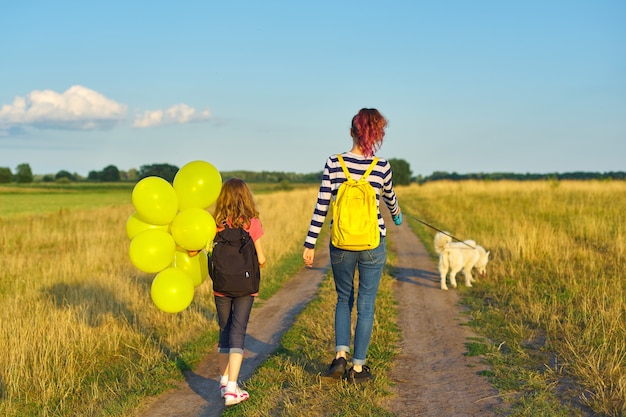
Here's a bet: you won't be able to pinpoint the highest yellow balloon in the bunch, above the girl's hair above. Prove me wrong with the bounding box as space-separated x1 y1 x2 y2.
174 161 222 211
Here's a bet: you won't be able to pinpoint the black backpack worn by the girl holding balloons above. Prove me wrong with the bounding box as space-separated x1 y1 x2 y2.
208 224 261 297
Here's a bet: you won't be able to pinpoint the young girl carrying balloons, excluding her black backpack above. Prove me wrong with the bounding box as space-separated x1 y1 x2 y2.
214 178 265 406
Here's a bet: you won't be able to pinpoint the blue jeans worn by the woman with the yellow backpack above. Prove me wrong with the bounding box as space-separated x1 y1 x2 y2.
330 236 387 365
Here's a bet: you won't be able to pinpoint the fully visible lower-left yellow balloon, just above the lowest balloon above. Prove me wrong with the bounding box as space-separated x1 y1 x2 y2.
128 229 176 274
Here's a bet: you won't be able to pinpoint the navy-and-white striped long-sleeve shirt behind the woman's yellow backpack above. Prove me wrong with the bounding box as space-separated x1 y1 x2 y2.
304 152 400 249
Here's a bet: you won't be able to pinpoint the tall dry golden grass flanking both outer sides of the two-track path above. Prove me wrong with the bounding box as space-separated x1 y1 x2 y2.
0 182 626 417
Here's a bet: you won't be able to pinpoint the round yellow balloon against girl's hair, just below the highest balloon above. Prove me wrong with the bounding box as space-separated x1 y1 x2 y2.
170 208 216 250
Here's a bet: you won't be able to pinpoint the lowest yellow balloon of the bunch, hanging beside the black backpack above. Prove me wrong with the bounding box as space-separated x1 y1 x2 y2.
150 268 194 313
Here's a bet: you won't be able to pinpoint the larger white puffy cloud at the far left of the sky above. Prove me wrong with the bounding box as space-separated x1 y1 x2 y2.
0 85 127 130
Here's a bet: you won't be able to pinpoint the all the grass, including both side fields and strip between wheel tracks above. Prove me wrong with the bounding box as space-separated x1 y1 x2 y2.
0 181 626 417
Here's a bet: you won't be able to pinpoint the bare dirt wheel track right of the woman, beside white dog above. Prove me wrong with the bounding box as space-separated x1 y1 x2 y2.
382 214 500 417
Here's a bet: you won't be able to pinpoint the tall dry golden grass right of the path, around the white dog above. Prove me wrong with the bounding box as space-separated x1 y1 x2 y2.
398 182 626 416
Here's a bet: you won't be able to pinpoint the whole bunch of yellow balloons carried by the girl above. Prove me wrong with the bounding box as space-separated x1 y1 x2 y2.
126 161 222 313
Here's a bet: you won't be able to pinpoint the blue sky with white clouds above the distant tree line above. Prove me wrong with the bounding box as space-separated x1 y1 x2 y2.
0 0 626 175
